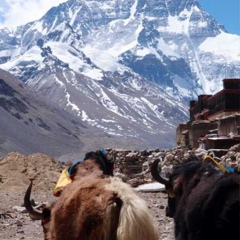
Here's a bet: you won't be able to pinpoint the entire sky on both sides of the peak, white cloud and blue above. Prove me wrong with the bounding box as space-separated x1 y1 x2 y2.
0 0 240 35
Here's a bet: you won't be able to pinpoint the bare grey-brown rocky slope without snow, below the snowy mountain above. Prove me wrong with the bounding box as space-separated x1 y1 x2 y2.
0 70 164 160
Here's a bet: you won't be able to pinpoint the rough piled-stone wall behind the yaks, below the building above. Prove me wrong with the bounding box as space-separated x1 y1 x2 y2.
108 144 240 187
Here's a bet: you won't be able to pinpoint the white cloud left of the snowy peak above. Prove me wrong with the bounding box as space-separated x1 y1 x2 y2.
0 0 67 28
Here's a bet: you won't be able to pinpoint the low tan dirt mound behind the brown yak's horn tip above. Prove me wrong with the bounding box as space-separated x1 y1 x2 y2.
0 152 62 190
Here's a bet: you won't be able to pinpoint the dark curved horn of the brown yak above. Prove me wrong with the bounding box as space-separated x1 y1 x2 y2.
24 180 43 220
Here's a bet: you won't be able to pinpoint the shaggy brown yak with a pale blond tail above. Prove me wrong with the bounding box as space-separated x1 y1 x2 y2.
24 149 159 240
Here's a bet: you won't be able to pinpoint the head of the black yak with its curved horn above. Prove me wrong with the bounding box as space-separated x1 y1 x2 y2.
151 157 201 217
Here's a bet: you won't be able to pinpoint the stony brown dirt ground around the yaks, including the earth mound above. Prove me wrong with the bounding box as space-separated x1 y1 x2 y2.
0 153 174 240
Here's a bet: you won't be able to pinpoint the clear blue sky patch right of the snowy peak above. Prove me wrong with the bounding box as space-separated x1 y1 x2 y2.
198 0 240 35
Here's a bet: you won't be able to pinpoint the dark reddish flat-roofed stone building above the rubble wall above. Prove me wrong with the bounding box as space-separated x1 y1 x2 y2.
176 78 240 149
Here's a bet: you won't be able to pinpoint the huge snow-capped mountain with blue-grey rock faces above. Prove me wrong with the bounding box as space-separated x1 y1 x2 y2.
0 0 240 147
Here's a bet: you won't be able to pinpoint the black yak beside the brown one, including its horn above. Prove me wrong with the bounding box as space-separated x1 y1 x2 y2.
151 157 240 240
